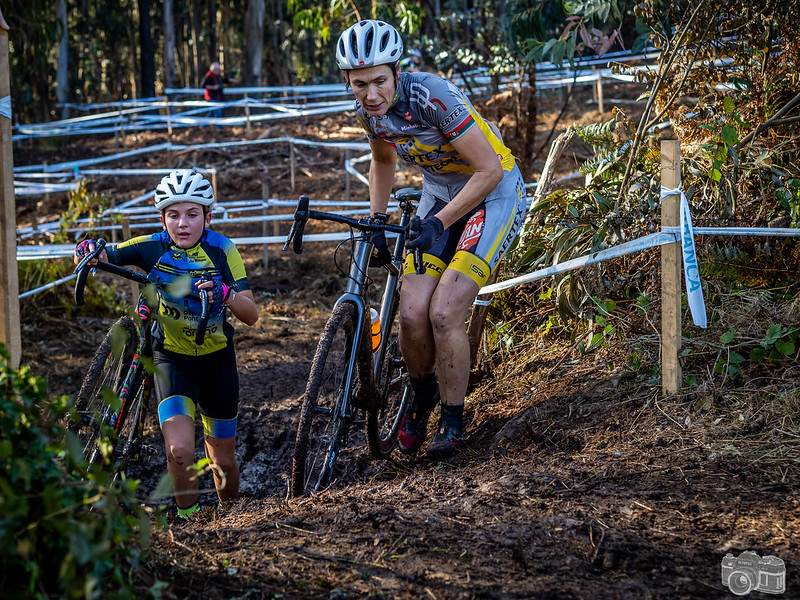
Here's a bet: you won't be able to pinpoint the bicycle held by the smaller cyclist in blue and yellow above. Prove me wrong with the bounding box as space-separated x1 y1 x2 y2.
68 239 210 478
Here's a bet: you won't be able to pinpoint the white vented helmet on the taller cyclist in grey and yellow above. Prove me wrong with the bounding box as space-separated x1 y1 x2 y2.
336 19 403 71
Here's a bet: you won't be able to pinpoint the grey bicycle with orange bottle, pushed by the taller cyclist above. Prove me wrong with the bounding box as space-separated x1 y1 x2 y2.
284 188 422 497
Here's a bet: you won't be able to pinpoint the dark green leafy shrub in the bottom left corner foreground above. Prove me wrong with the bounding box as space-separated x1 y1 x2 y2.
0 345 159 599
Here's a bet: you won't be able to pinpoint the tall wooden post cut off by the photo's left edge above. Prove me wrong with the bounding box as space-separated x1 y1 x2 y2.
0 12 22 369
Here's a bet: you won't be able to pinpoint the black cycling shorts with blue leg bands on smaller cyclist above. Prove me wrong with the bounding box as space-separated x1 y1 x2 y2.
153 344 239 439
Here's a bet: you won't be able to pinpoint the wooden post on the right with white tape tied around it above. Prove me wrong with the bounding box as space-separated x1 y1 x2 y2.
661 140 682 396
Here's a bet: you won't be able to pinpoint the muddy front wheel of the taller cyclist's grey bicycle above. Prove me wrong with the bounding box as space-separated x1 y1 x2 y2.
292 303 356 496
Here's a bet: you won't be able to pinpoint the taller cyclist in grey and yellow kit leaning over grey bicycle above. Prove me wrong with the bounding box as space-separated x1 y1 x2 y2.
336 20 526 458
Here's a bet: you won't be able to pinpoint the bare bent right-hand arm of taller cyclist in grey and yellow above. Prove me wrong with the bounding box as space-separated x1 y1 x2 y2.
432 125 503 229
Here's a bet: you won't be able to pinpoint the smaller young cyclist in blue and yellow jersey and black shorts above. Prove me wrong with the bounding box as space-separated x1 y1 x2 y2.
75 170 258 518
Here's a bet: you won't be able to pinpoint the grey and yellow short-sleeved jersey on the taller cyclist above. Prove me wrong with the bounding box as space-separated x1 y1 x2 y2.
355 73 514 189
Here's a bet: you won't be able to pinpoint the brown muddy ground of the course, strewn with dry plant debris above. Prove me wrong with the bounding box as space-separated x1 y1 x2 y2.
15 82 800 600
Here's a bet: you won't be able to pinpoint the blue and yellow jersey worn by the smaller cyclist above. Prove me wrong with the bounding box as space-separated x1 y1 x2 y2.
106 229 250 356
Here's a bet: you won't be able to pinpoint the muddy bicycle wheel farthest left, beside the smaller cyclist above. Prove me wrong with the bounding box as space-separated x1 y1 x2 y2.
69 317 139 464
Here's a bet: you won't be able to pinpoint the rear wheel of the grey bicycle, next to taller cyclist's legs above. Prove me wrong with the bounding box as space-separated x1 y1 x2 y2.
367 297 412 458
